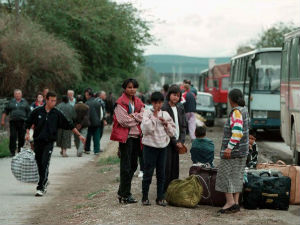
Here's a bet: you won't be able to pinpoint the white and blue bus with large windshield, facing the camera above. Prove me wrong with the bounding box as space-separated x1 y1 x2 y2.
228 48 281 131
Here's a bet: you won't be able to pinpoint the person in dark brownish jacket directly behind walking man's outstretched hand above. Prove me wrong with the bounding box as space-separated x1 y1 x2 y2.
74 95 90 157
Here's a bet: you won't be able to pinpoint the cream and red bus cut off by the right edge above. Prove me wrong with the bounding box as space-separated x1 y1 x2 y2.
280 28 300 165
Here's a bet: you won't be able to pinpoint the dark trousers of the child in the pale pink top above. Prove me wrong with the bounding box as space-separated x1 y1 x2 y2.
142 145 167 200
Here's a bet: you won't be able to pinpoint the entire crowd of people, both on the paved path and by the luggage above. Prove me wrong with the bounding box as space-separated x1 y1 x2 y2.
1 79 257 213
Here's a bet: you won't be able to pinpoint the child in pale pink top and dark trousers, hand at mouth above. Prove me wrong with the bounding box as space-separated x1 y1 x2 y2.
141 92 176 206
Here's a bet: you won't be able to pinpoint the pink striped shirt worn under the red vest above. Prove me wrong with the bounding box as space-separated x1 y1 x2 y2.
115 104 144 137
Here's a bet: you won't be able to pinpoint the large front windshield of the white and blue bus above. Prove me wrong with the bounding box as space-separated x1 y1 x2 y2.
252 52 281 92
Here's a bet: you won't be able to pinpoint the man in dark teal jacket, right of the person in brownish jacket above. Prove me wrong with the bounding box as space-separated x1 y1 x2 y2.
84 88 102 155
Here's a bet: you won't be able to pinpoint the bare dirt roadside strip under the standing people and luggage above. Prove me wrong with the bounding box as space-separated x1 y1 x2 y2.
26 121 300 225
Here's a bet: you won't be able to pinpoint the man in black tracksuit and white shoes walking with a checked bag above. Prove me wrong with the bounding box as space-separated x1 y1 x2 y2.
25 92 85 196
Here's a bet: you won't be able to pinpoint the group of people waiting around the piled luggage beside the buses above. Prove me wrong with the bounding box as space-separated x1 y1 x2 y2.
110 79 257 213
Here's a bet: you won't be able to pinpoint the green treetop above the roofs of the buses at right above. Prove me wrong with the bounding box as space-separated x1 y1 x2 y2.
252 22 296 48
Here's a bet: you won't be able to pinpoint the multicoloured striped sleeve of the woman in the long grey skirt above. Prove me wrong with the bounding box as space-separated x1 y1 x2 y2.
227 109 243 149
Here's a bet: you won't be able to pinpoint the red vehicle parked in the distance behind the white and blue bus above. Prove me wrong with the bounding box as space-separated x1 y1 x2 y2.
199 63 230 117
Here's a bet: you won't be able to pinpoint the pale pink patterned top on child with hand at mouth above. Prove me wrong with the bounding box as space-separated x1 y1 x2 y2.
141 110 176 148
